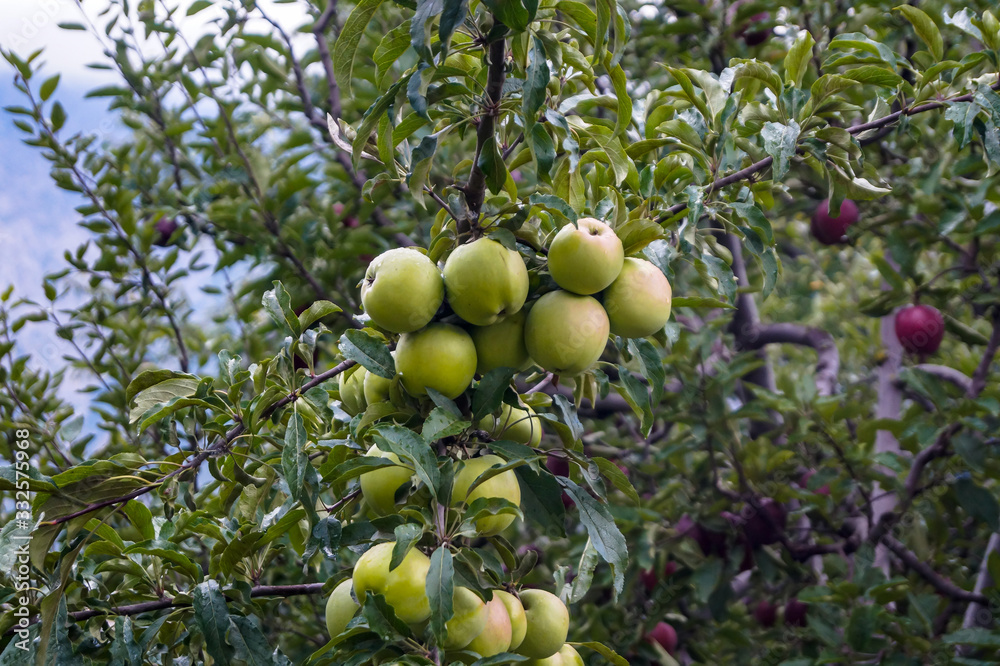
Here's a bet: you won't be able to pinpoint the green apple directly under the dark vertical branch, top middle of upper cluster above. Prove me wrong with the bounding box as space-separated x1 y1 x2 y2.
444 238 528 326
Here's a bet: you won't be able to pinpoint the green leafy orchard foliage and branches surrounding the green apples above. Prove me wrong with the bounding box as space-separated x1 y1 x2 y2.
0 0 1000 666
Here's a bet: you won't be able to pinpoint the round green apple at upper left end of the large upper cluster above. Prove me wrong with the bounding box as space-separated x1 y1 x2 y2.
361 247 444 333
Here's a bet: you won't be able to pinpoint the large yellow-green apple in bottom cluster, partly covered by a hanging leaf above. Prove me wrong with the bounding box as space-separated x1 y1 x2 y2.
354 541 431 624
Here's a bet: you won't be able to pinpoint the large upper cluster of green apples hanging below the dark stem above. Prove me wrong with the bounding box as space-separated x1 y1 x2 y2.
341 218 671 413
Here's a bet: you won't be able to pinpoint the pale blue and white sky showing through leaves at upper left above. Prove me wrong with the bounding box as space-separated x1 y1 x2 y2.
0 0 305 426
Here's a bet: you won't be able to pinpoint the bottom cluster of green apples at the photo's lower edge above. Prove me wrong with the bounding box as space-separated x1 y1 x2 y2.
326 542 583 666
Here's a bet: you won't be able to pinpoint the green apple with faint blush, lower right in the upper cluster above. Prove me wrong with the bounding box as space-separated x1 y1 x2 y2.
524 291 610 376
